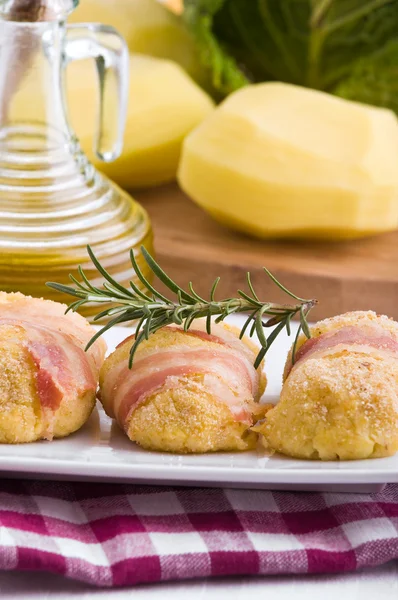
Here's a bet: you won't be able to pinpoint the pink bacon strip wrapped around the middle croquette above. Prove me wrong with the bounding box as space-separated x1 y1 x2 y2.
101 327 258 427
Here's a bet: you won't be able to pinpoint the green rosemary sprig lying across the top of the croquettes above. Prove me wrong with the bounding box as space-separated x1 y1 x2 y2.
47 246 316 368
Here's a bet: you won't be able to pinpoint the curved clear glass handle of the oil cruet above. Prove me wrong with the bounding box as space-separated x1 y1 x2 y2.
64 23 129 162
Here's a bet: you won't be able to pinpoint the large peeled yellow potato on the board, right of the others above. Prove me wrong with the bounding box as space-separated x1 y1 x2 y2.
178 83 398 239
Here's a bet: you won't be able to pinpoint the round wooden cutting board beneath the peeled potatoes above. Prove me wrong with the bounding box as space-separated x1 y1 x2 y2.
135 184 398 319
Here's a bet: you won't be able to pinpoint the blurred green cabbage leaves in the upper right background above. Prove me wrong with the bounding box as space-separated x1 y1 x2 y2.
184 0 398 111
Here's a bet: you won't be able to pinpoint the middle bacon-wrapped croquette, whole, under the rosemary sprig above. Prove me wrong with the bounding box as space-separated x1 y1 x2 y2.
100 320 265 453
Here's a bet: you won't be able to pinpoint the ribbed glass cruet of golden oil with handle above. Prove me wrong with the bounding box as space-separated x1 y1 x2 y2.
0 0 152 318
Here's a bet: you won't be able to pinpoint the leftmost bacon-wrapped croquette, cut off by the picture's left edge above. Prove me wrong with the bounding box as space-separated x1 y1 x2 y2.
0 292 106 443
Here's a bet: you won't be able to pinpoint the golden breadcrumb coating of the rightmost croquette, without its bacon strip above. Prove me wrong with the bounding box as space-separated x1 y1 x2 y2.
256 311 398 460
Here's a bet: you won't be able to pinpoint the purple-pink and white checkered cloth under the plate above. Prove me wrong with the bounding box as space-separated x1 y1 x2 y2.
0 481 398 586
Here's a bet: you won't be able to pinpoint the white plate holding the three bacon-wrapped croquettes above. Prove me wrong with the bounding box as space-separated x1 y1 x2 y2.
0 317 398 492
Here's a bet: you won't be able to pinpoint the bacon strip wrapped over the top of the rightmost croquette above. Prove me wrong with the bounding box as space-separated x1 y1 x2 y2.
285 325 398 378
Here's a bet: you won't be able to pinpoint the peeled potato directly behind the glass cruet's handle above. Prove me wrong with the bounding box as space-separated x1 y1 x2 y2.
67 55 213 189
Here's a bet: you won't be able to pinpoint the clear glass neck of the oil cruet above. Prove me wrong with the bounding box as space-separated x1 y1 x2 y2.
0 19 72 146
